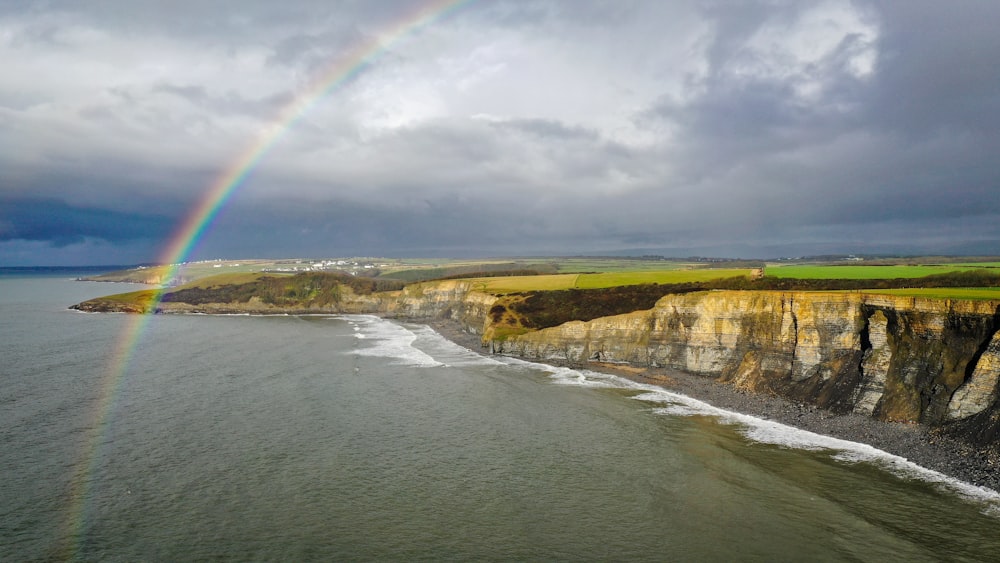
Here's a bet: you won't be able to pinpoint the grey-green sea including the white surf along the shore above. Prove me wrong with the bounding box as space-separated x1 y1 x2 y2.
0 272 1000 561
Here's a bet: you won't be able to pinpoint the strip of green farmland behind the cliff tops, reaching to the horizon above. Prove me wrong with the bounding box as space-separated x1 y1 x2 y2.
80 257 1000 299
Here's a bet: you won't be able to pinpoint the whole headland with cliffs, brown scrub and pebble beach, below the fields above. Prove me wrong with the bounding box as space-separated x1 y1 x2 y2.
74 260 1000 490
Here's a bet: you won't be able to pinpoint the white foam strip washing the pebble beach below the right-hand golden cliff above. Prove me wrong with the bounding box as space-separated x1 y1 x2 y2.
510 358 1000 518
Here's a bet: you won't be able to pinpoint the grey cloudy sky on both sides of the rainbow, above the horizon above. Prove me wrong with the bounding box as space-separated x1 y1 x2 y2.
0 0 1000 266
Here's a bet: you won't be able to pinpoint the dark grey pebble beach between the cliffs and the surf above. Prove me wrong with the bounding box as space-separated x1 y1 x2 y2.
418 319 1000 493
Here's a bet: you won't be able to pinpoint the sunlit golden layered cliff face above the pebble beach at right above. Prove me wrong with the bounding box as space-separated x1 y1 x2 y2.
492 291 1000 438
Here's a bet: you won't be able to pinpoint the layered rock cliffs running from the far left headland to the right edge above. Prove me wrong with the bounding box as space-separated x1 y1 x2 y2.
75 278 1000 444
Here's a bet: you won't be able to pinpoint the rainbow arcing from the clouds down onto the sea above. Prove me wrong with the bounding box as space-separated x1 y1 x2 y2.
63 0 475 559
